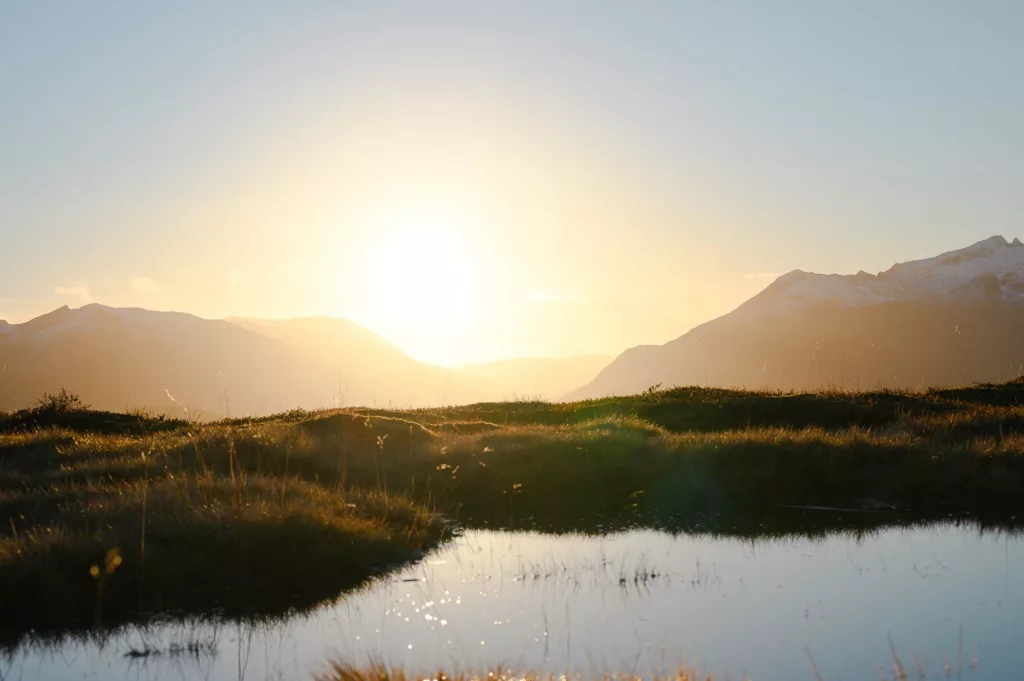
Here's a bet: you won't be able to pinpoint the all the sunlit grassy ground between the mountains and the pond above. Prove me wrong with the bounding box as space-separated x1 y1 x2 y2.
6 382 1024 638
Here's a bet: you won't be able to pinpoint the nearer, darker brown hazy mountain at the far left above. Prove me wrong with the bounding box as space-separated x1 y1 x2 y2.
0 304 311 416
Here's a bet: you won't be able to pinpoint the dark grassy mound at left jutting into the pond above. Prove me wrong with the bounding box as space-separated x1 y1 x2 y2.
0 417 444 641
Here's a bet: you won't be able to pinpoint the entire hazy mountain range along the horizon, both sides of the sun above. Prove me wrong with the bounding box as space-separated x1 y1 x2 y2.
0 237 1024 411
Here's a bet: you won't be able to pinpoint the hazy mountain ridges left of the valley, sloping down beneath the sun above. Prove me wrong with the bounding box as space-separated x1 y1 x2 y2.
0 304 487 411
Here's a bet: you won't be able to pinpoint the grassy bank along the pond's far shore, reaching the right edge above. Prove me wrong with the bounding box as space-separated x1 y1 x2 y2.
211 382 1024 524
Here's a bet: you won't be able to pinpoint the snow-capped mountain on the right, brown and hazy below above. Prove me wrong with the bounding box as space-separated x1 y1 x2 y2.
570 237 1024 398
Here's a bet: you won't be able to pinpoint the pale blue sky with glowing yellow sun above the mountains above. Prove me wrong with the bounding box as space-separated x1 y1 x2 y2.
0 0 1024 366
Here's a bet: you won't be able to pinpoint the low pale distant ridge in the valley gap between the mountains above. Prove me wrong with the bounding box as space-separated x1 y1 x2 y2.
459 354 613 400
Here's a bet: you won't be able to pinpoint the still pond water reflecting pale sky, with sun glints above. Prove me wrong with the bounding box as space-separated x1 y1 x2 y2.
0 525 1024 681
